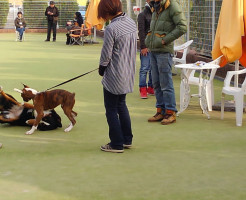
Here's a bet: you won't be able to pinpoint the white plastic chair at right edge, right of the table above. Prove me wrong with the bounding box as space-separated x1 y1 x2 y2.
221 69 246 126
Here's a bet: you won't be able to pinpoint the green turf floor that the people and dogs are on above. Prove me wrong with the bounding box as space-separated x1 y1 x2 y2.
0 33 246 200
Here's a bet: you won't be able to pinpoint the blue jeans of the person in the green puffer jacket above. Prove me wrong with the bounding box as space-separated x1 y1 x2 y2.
150 52 177 114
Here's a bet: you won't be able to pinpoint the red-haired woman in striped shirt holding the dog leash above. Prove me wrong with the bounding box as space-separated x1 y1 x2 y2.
98 0 137 153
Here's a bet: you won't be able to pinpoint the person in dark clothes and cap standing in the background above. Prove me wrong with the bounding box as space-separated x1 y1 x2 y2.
45 1 59 42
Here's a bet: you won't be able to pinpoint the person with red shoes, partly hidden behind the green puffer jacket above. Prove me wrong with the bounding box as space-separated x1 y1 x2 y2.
138 0 154 99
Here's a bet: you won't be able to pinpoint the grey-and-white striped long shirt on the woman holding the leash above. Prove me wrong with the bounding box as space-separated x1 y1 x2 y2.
100 14 137 95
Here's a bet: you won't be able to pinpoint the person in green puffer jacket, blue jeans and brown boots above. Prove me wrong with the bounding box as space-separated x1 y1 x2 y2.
145 0 187 125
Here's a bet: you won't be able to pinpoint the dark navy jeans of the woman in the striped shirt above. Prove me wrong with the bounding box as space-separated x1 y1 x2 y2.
103 89 133 149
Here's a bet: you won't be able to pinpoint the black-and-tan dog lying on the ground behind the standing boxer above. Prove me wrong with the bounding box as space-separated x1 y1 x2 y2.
0 86 62 131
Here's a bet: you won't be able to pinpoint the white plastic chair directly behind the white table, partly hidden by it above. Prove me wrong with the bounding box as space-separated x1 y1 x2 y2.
189 55 223 111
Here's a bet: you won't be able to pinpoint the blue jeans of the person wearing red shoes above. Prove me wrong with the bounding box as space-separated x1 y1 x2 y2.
139 53 152 87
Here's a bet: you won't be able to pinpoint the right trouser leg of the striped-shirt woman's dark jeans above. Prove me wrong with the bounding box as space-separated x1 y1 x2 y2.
118 94 133 145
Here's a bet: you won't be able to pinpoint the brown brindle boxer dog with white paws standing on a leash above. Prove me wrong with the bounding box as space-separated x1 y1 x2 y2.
15 84 77 135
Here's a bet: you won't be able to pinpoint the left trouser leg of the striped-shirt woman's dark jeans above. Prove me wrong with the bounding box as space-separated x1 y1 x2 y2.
103 89 124 149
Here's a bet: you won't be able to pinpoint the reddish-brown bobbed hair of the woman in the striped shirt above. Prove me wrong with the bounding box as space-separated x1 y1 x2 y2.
97 0 122 20
